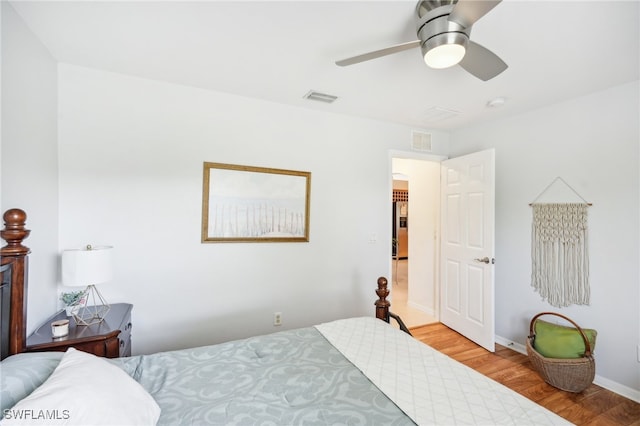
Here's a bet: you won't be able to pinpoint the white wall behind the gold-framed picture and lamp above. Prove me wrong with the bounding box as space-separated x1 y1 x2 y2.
59 65 448 353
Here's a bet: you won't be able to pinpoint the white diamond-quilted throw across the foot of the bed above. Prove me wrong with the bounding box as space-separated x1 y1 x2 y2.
316 318 571 425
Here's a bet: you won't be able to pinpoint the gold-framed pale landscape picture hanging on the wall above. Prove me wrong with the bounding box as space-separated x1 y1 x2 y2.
202 162 311 243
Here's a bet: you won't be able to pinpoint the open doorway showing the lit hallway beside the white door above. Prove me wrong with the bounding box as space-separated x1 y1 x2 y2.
390 152 443 327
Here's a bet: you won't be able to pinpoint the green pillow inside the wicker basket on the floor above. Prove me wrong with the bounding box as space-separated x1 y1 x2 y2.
533 320 597 359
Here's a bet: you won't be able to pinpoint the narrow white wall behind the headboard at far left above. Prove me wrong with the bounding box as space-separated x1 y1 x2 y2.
0 1 58 332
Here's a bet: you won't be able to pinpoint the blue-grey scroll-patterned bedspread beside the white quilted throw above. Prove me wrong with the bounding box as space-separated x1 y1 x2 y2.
114 327 414 426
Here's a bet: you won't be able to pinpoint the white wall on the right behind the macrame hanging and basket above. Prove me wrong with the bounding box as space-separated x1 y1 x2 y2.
451 82 640 398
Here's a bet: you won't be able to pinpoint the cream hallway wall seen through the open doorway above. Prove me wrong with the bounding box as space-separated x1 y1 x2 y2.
391 158 441 317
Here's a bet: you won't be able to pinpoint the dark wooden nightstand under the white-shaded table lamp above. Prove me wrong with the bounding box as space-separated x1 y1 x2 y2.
26 303 133 358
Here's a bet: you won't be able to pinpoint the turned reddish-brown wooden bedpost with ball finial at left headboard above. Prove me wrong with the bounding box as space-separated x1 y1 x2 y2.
0 209 31 355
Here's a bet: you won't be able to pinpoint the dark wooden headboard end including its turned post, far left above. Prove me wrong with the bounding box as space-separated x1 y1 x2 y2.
0 209 31 359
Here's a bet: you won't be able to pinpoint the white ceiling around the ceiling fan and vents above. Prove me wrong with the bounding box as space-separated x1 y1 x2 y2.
11 0 640 130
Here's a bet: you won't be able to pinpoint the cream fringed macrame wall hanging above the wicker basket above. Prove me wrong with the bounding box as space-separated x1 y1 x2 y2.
530 177 591 307
